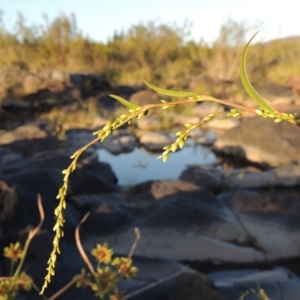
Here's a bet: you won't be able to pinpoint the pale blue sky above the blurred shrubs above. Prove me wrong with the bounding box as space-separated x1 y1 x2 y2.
0 0 300 42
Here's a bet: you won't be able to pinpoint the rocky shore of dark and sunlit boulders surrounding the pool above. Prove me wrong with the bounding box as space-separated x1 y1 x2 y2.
0 72 300 300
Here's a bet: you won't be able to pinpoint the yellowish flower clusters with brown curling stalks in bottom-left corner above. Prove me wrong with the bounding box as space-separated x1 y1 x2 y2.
0 195 140 300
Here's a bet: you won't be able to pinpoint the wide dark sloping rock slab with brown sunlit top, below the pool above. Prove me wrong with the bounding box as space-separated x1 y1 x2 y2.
83 181 264 263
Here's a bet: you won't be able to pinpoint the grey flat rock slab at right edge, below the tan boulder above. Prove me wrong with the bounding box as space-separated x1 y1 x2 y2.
218 190 300 261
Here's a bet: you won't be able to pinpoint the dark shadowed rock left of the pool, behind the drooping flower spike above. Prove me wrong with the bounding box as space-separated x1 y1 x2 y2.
0 150 117 240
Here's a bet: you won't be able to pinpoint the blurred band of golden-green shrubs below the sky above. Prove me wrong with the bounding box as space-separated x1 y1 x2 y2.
0 14 300 97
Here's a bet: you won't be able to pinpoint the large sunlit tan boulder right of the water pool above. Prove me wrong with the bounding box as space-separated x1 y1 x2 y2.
214 117 300 166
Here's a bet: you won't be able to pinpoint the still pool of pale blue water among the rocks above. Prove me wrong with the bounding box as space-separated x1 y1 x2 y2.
98 145 216 185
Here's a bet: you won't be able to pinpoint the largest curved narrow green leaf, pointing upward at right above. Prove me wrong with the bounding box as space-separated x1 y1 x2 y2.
240 32 275 112
